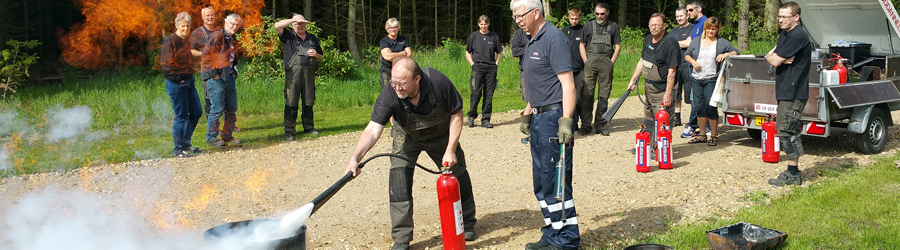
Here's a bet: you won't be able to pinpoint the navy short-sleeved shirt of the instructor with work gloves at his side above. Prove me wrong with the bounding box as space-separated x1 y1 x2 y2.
522 21 572 107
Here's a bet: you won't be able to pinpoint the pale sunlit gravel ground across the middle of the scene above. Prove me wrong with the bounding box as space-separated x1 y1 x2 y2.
0 98 900 249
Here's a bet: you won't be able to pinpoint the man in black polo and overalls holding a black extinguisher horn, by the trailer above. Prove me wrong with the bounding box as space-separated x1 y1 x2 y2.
628 13 684 146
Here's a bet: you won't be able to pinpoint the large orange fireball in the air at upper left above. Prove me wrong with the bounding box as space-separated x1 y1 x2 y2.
59 0 265 69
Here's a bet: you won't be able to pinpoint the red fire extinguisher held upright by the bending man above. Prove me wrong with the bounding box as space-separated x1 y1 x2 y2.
437 162 466 250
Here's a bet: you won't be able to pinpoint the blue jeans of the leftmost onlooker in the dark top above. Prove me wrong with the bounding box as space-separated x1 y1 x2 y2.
166 78 203 153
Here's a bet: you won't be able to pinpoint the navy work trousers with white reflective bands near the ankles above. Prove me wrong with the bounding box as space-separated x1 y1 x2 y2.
531 109 581 249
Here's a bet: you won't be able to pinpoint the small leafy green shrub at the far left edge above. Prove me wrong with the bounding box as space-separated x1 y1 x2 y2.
0 40 41 99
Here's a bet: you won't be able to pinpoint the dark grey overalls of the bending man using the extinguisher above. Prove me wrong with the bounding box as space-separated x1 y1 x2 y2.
388 78 476 243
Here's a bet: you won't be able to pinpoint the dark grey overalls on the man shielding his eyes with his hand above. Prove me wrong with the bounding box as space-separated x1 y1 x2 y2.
284 40 319 134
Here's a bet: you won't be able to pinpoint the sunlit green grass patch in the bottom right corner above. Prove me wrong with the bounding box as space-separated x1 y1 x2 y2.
628 154 900 249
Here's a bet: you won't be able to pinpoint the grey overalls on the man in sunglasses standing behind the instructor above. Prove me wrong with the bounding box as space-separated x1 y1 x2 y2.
581 21 615 130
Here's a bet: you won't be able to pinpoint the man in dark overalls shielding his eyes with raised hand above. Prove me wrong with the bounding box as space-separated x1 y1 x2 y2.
275 14 322 141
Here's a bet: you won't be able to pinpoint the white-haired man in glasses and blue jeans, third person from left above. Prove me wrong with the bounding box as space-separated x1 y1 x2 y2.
200 13 242 147
